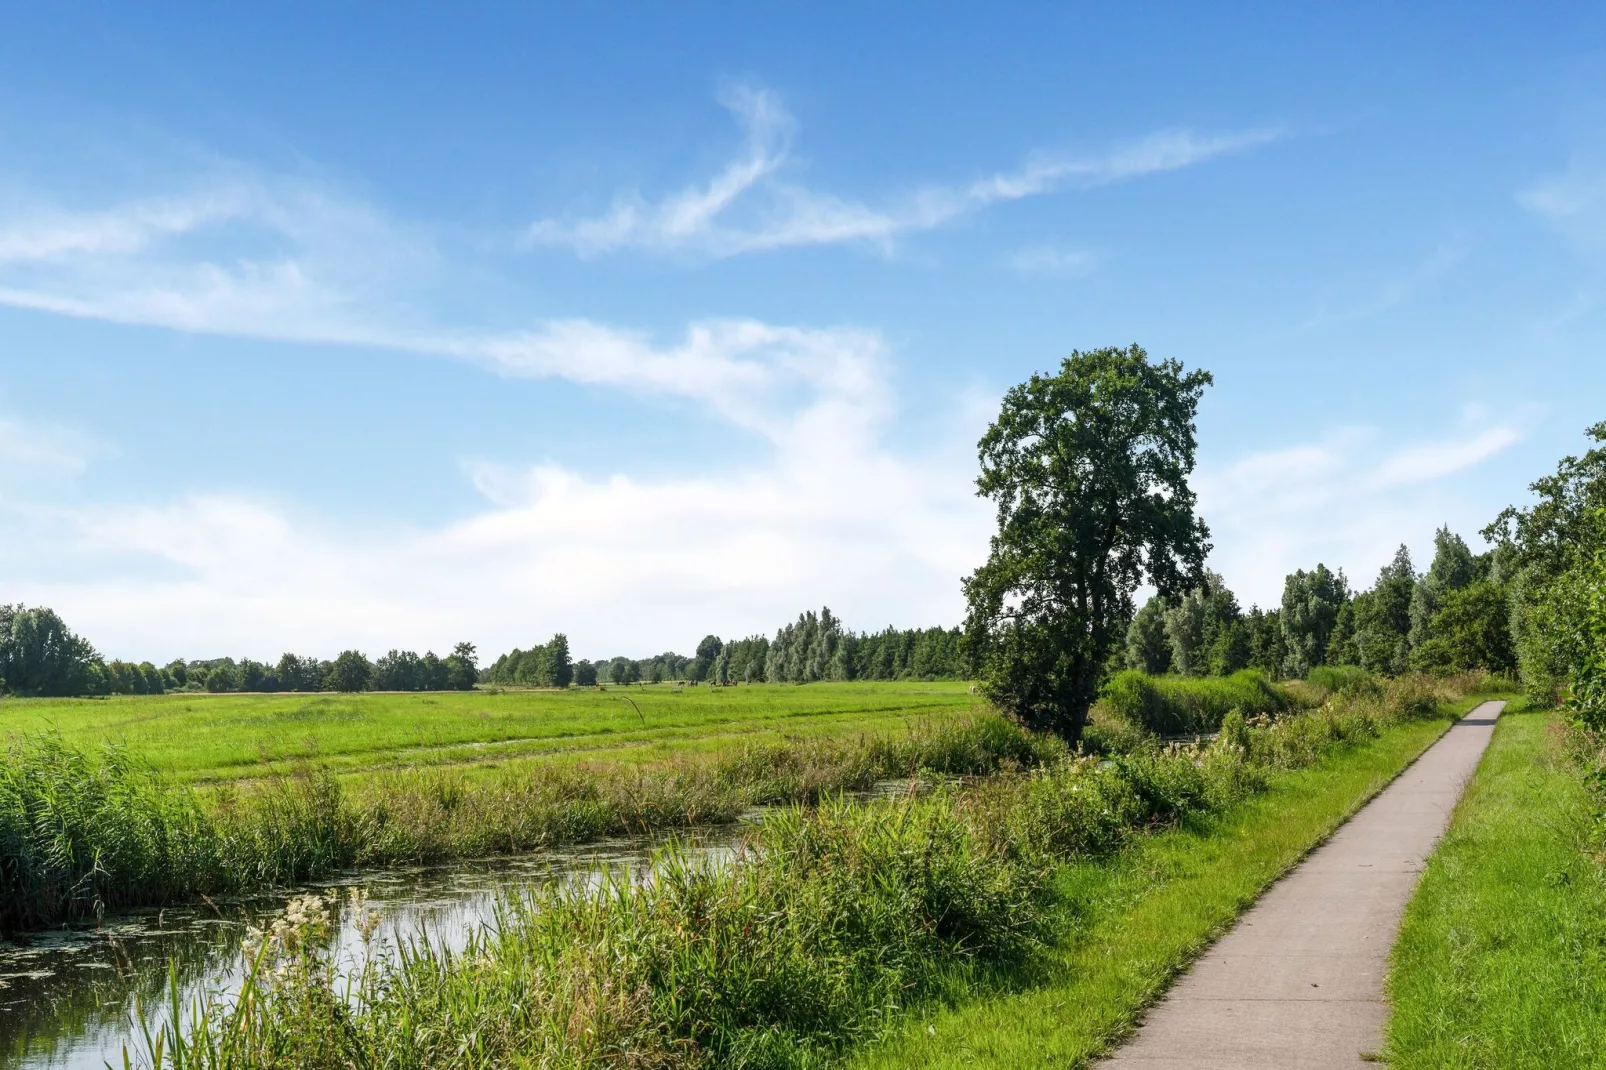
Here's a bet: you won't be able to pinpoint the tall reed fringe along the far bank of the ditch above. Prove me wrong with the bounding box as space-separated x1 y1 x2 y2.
0 715 1065 932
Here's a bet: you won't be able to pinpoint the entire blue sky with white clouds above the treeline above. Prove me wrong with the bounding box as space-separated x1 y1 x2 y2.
0 5 1606 660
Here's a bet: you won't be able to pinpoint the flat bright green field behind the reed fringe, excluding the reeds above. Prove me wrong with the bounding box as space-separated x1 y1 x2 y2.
0 681 980 782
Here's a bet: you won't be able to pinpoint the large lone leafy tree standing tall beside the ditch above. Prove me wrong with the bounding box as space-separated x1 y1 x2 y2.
965 345 1211 739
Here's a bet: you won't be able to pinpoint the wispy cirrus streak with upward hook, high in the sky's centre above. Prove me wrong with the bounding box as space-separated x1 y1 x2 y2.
525 87 1282 257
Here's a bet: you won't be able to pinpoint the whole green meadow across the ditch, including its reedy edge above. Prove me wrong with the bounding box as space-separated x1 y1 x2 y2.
0 683 1065 932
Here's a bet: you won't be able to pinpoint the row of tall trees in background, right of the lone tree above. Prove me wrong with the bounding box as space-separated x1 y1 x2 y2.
1123 529 1516 676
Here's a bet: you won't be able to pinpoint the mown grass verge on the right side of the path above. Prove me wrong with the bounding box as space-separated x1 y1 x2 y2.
1384 709 1606 1070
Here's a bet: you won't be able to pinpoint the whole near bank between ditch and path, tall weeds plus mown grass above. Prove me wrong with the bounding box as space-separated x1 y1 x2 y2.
125 680 1476 1070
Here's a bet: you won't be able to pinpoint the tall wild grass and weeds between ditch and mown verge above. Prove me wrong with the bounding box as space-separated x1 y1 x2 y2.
131 681 1471 1070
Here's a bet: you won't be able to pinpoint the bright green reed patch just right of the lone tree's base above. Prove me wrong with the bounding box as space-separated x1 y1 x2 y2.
1099 668 1293 736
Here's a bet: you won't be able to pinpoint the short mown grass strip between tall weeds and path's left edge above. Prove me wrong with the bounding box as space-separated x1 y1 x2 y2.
851 696 1486 1070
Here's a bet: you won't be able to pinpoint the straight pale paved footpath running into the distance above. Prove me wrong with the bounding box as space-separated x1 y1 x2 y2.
1099 702 1505 1070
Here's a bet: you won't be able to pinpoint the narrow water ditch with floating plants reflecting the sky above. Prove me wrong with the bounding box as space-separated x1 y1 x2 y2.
0 779 909 1070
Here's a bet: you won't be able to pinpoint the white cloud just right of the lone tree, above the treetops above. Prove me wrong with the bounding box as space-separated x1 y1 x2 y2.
1195 423 1522 606
